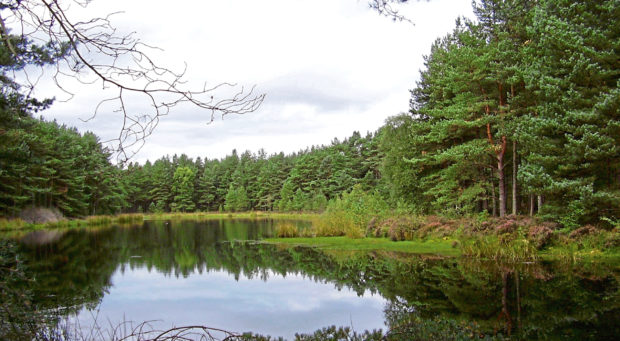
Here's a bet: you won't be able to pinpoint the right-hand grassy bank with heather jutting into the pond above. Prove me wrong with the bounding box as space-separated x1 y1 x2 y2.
265 212 620 262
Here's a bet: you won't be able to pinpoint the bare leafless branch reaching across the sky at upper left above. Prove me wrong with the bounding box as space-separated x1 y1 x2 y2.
0 0 265 163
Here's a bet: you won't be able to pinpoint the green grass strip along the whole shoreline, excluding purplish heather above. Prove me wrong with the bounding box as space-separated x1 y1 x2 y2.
0 211 620 263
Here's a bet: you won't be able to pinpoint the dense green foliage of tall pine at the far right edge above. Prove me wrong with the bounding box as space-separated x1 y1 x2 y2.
521 0 620 224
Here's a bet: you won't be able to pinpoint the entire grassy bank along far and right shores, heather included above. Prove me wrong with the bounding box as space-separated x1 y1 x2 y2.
0 210 620 263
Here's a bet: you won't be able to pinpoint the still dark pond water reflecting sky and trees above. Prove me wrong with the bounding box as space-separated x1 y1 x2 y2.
2 220 620 340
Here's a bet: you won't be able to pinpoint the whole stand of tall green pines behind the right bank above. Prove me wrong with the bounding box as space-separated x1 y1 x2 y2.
379 0 620 228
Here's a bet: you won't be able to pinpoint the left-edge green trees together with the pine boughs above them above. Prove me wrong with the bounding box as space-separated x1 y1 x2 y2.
0 31 125 217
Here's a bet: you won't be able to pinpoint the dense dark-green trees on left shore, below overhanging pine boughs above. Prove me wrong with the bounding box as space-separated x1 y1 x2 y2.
0 114 125 217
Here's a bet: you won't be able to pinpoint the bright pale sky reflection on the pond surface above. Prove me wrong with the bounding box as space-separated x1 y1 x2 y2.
79 267 386 339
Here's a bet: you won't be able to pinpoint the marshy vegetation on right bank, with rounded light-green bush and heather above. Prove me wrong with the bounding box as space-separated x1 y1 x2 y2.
270 187 620 261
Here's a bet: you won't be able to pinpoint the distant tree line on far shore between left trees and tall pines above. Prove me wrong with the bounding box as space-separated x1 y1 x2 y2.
123 132 380 212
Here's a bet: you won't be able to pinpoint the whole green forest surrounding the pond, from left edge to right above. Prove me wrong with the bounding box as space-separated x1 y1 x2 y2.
0 0 620 229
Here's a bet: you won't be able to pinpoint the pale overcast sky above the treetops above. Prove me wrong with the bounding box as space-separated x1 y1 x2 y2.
38 0 473 162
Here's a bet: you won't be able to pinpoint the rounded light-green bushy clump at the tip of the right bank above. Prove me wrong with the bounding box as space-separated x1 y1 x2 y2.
315 185 388 238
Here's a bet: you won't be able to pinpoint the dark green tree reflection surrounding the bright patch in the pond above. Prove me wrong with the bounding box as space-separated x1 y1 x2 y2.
2 220 620 340
